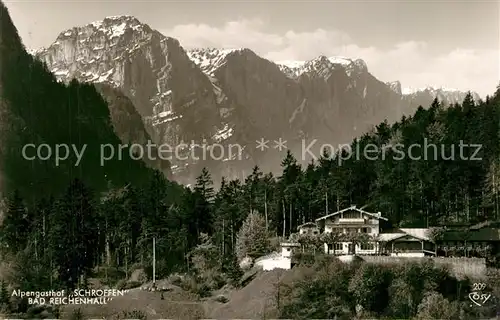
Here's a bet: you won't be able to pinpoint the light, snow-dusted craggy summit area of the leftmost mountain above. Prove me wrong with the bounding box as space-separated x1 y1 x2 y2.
35 15 184 87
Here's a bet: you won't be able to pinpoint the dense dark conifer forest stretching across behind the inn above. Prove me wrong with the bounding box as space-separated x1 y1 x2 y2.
1 86 500 292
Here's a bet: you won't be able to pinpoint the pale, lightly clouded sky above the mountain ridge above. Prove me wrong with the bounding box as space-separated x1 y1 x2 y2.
4 0 500 96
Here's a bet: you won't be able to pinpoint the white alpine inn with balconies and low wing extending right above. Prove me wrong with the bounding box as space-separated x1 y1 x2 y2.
298 206 500 257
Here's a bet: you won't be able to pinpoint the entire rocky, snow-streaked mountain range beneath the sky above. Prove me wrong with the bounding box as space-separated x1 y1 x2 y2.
33 16 479 183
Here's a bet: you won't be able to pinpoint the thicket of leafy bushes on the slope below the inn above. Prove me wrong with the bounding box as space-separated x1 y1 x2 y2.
279 258 488 320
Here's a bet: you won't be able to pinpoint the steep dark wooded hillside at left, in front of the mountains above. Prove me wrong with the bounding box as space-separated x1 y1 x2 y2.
0 4 156 203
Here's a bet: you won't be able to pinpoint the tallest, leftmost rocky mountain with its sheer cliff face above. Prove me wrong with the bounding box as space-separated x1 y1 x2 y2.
37 16 218 143
